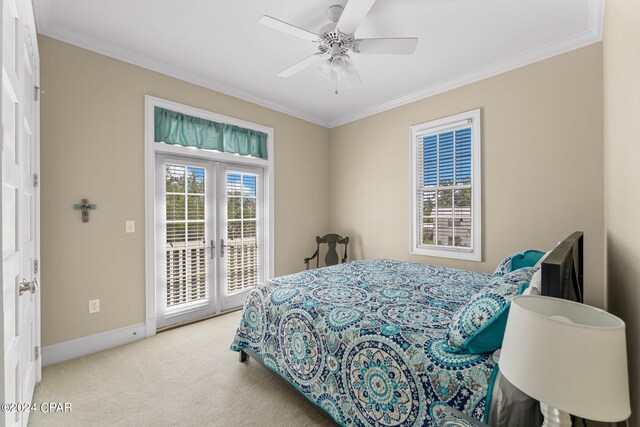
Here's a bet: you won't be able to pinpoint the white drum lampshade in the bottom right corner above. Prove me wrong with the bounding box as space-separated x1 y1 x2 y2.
500 296 631 422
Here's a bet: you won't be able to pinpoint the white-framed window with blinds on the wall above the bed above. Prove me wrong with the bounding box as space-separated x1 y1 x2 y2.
411 110 482 261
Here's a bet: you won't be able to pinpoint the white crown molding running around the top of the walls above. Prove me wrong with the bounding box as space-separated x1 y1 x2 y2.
34 0 604 128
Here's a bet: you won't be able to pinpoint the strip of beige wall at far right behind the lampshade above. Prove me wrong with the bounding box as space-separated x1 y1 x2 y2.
604 0 640 426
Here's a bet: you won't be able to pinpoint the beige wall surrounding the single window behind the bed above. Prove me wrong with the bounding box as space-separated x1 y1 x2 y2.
330 44 604 306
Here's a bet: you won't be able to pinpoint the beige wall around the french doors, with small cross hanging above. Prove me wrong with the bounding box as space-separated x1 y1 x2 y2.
39 37 329 345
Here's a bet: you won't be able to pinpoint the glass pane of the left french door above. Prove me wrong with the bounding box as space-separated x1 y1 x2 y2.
165 165 207 307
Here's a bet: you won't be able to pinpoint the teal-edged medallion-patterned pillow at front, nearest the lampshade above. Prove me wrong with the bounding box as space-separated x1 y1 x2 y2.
445 267 536 354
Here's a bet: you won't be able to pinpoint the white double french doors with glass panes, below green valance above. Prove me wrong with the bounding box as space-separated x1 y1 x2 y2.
155 155 264 327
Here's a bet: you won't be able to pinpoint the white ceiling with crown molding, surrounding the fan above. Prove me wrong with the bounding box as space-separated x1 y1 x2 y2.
34 0 603 127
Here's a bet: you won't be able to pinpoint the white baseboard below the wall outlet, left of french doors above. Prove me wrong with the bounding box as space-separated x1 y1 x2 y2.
42 323 145 366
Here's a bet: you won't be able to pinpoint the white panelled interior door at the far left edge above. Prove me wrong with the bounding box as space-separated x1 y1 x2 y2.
1 0 40 425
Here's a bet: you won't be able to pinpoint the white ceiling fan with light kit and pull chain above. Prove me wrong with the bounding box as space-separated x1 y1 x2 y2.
258 0 418 95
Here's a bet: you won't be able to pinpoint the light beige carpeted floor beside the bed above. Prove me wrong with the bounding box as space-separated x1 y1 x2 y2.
29 312 334 426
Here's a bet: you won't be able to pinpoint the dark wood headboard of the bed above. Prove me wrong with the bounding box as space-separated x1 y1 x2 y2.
542 231 584 302
